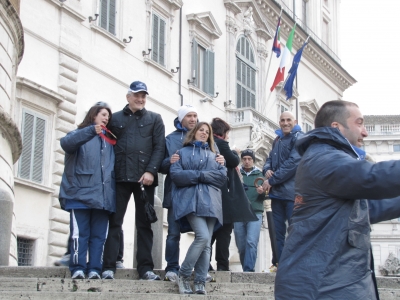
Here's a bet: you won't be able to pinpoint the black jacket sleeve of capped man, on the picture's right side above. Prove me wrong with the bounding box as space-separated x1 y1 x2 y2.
145 114 165 176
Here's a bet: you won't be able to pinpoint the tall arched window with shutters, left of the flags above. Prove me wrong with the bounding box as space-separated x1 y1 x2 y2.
236 36 256 108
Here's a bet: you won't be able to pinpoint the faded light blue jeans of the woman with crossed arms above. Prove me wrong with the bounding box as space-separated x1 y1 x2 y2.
179 214 216 283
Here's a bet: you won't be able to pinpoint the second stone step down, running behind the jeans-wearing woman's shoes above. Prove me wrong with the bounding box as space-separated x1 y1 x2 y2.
0 277 274 297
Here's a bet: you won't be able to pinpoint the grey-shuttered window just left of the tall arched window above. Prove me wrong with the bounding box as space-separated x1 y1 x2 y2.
192 39 215 96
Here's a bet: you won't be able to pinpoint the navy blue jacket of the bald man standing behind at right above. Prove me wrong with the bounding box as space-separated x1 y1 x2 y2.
263 125 303 201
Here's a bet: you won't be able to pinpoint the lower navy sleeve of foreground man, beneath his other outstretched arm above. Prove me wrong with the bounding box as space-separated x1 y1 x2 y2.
368 197 400 224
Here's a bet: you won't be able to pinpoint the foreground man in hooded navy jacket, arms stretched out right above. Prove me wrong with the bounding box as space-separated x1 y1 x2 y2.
275 100 400 300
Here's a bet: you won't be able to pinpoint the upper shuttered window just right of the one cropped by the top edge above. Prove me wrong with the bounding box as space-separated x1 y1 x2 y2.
151 13 166 66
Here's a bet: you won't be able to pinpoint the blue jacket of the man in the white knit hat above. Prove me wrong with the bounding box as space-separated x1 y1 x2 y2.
160 118 188 208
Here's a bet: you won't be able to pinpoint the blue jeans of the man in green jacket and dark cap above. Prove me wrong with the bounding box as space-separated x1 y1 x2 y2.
233 213 262 272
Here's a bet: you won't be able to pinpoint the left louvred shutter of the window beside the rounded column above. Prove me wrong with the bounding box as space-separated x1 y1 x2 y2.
19 113 35 179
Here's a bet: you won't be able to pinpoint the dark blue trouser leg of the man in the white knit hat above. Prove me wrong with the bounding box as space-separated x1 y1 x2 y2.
165 206 181 274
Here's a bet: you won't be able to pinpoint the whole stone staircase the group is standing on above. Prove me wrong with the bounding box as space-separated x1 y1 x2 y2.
0 267 400 300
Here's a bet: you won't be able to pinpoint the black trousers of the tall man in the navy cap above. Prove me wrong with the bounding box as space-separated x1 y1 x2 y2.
103 182 154 277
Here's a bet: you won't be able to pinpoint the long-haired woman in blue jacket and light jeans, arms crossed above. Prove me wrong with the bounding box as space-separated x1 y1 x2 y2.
170 122 226 295
